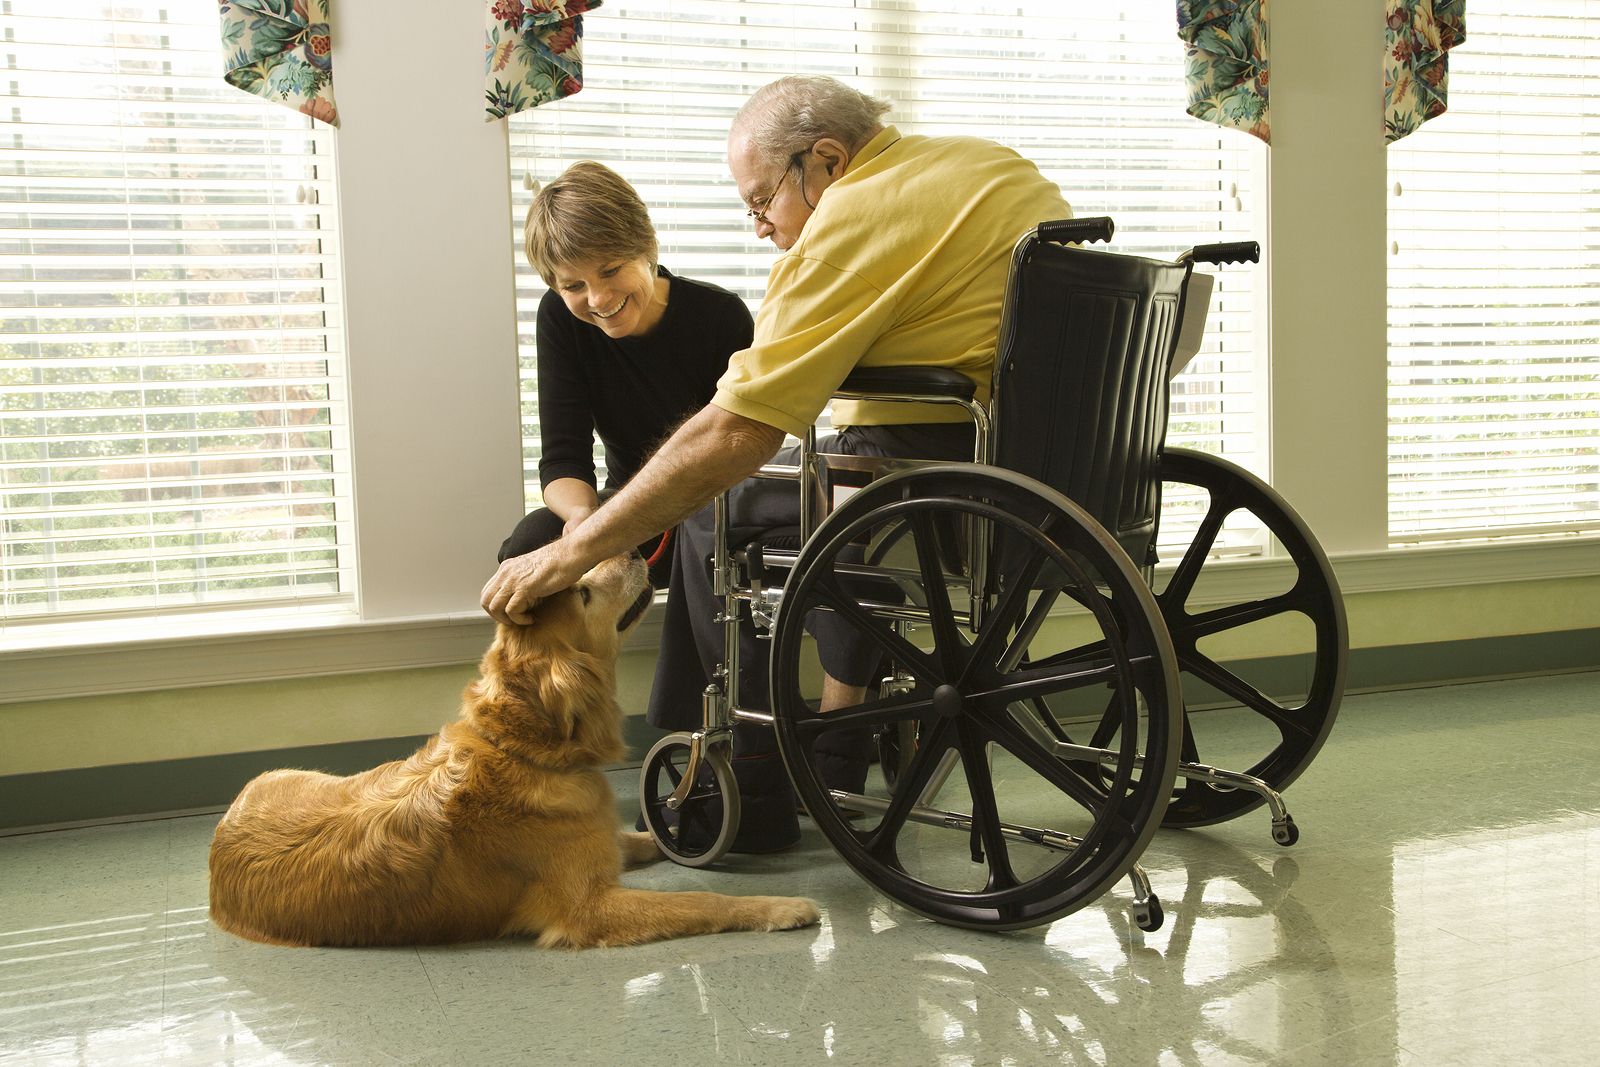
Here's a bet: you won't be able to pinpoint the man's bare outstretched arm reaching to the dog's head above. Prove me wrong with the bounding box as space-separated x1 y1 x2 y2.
480 405 784 622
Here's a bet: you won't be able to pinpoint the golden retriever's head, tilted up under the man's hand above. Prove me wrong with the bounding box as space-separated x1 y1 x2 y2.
466 552 651 766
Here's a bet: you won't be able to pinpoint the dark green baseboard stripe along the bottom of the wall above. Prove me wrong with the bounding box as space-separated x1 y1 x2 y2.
0 629 1600 833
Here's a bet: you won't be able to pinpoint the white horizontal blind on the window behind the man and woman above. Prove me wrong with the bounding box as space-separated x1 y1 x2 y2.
510 0 1261 550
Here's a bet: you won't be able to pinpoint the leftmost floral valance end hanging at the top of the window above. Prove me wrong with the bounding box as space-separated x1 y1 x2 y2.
218 0 339 126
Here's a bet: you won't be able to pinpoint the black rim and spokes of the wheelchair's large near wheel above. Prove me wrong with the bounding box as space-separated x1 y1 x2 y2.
771 464 1182 929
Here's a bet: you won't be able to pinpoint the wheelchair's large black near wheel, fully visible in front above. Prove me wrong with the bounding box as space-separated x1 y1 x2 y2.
771 466 1182 929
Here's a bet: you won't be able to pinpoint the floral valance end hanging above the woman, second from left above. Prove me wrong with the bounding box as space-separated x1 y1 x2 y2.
483 0 600 122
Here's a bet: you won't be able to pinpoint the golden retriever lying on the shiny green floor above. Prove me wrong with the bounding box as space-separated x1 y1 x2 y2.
211 553 818 947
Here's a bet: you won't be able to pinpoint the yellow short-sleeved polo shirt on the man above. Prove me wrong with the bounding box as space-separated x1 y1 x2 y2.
712 126 1072 435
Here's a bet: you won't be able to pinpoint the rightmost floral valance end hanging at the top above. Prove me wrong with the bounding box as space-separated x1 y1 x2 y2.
1384 0 1467 141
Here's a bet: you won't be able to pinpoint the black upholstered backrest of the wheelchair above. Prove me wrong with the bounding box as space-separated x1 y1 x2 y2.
994 221 1190 563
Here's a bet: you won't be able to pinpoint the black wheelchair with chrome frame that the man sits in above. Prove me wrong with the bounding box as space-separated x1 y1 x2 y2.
640 218 1349 929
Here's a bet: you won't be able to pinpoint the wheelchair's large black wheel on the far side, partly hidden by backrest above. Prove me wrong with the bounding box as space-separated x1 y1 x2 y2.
1157 448 1349 827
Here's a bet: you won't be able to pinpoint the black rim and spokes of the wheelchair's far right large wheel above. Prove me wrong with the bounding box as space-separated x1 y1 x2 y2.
1157 448 1349 843
